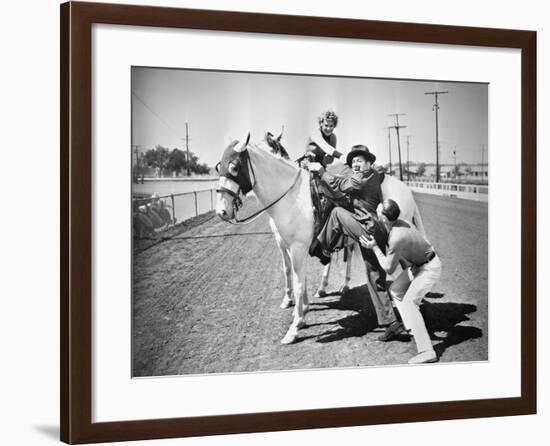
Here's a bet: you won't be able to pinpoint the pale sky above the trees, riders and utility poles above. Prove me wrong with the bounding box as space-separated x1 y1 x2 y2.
131 67 488 166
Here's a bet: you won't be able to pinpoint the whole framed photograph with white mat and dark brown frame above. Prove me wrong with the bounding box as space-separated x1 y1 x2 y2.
61 2 536 444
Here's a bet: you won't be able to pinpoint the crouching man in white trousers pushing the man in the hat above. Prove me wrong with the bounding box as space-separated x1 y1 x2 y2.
360 199 441 364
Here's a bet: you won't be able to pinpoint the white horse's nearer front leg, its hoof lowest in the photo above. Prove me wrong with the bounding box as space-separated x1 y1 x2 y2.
281 246 307 344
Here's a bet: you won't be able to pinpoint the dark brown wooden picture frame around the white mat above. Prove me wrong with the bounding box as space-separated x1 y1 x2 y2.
60 2 537 444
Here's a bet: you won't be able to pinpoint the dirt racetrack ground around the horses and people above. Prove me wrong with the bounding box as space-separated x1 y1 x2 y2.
132 194 488 376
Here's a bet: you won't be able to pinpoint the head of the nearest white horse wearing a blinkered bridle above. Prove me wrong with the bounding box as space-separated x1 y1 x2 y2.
216 133 253 220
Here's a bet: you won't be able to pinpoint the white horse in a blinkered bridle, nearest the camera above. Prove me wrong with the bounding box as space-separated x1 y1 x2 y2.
216 135 421 344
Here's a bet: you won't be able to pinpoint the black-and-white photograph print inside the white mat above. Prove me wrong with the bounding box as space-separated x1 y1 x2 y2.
132 67 490 377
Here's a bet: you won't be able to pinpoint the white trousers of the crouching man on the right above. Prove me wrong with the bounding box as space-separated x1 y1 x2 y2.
389 255 441 353
